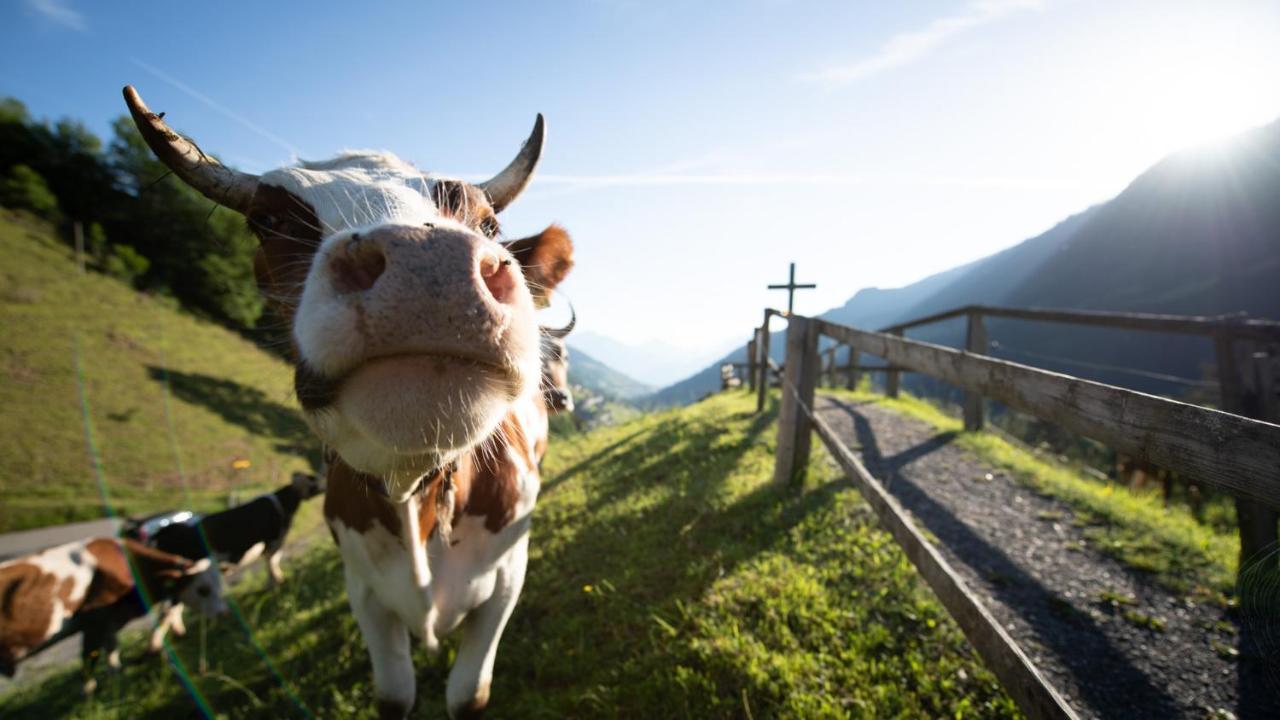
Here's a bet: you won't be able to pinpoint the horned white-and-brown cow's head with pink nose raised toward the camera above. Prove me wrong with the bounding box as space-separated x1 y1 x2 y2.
124 87 572 500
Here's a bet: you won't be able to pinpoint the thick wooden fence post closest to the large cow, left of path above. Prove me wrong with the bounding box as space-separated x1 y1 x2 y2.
773 315 819 487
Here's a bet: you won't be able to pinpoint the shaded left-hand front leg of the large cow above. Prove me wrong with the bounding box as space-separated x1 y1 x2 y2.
347 571 416 720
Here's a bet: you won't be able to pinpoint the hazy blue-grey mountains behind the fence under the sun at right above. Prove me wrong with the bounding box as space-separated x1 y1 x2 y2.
646 120 1280 406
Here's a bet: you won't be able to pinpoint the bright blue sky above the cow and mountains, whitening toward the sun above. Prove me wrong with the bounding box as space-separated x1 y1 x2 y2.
0 0 1280 366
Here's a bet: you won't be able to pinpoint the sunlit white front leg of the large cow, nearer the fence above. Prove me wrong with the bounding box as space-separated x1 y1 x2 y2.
444 533 529 719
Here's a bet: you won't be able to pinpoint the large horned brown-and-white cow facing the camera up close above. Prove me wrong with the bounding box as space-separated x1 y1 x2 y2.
124 87 573 717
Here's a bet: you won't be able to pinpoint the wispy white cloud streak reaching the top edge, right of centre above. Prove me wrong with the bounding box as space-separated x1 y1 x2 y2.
800 0 1042 87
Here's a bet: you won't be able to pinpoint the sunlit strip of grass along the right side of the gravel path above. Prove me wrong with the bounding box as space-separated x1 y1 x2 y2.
826 391 1240 594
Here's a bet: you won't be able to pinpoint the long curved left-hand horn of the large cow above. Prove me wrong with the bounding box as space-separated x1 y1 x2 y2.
124 85 257 213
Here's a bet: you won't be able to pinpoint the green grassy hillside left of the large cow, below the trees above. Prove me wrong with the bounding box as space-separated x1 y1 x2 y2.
0 211 314 532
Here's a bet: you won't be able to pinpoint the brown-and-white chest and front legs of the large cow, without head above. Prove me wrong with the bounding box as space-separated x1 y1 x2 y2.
325 397 547 715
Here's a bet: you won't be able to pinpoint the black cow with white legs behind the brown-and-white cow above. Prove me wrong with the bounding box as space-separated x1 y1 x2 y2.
147 473 324 652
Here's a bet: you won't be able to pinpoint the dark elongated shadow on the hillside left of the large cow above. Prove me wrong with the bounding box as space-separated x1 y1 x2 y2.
147 365 320 468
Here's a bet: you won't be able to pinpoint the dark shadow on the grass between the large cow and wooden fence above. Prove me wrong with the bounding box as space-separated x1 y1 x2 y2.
483 394 875 717
